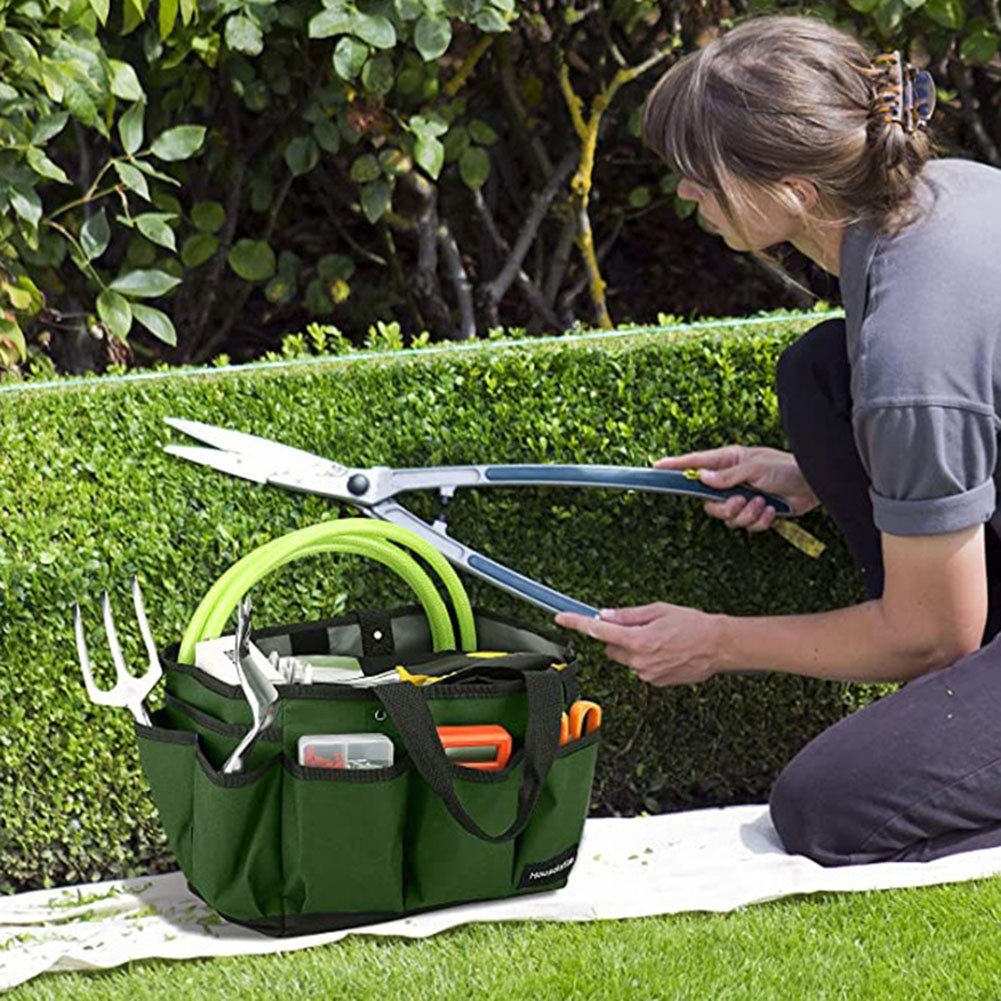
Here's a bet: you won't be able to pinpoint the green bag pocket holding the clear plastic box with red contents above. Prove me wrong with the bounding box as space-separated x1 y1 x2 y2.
282 755 413 920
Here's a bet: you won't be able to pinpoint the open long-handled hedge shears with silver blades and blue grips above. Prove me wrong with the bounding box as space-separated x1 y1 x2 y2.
164 417 792 618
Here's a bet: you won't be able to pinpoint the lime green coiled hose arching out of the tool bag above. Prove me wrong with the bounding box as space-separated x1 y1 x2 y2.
177 518 476 664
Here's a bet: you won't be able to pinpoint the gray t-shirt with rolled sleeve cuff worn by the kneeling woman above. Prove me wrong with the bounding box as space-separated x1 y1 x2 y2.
840 158 1001 536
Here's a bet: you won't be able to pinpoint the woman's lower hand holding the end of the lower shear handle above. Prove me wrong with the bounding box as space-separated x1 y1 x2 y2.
556 602 722 686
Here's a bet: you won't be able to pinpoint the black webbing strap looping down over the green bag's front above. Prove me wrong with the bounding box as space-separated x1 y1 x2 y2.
371 670 563 844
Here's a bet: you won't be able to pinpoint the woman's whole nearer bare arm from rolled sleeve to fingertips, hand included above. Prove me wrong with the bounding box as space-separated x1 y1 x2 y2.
556 525 987 685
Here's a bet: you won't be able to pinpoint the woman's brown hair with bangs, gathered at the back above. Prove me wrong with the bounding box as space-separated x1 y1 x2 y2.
643 14 937 264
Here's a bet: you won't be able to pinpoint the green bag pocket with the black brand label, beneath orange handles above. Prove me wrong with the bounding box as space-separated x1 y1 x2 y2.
513 730 601 893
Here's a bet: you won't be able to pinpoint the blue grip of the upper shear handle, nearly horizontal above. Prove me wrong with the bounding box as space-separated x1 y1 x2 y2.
483 465 793 515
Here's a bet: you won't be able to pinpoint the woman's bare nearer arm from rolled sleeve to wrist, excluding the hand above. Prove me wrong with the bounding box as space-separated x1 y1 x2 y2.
716 525 990 682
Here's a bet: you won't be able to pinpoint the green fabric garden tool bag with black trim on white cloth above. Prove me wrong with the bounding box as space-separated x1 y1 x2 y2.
135 523 601 936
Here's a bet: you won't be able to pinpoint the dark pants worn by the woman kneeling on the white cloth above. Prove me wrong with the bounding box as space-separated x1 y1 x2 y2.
769 319 1001 866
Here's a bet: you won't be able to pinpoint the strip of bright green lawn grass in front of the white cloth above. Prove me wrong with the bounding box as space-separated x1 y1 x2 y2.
6 878 1001 1001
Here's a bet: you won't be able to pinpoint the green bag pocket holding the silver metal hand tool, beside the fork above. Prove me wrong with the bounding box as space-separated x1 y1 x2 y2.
188 748 283 921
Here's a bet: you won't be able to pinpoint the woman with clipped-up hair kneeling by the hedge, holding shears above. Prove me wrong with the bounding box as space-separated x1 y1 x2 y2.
556 16 1001 865
